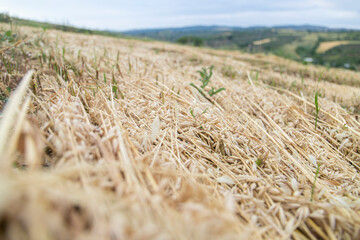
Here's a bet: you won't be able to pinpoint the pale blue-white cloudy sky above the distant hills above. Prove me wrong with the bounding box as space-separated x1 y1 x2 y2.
0 0 360 30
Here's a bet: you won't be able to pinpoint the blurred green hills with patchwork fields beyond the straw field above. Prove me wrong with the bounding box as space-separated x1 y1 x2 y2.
124 25 360 70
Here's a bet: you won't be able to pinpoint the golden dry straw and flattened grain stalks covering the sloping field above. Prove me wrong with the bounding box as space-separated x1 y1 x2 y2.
0 25 360 240
